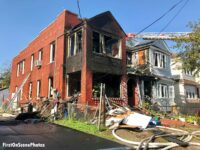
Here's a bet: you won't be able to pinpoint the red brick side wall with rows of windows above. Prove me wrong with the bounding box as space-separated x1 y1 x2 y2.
10 10 80 104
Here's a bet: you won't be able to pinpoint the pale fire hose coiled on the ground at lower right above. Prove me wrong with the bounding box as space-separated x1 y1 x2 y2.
112 126 200 150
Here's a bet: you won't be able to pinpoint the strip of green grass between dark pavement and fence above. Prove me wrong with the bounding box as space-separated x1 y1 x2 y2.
54 119 115 140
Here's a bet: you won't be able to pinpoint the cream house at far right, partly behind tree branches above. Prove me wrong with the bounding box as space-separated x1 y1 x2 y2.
171 54 200 114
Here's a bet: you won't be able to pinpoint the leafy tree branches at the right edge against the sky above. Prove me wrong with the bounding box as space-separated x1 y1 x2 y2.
175 21 200 74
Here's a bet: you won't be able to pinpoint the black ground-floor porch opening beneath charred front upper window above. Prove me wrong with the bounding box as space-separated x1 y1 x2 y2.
92 73 120 98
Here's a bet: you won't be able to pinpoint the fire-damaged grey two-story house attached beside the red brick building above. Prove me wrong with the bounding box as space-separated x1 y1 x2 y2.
127 40 174 111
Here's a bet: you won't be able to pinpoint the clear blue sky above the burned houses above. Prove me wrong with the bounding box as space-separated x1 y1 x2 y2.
0 0 200 67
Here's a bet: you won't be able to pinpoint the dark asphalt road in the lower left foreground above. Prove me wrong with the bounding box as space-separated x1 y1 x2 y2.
0 121 128 150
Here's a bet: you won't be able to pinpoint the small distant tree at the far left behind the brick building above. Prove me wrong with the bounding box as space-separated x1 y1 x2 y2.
0 66 10 87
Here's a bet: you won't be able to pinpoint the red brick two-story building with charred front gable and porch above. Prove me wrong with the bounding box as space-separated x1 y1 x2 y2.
10 10 127 105
